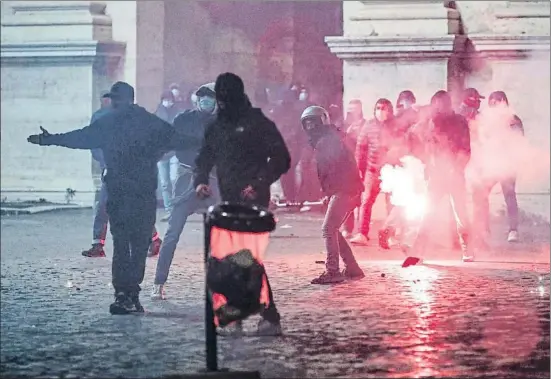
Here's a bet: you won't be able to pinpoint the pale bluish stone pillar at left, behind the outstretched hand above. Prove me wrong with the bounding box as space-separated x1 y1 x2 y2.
1 1 124 204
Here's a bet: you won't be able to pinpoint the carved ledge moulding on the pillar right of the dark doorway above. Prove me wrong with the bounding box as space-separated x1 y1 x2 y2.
325 35 454 60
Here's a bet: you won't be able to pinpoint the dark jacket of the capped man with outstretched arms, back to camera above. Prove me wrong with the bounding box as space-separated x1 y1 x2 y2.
41 104 188 197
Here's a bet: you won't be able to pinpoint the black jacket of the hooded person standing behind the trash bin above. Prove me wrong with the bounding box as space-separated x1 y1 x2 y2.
194 104 291 207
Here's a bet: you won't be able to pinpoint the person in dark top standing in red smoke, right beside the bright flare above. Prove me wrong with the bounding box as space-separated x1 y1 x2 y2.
412 91 474 262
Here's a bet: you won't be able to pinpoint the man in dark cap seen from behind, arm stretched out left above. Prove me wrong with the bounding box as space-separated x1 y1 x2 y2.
27 82 192 314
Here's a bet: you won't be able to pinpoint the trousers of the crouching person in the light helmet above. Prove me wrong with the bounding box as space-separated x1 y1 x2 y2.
322 193 360 273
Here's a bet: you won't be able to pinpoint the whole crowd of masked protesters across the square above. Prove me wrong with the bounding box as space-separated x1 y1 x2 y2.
28 73 524 320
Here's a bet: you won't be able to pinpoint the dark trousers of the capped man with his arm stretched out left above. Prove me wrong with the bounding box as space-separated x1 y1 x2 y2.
107 191 157 294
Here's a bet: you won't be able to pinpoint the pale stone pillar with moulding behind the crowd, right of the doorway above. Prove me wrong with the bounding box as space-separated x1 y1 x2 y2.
325 1 459 116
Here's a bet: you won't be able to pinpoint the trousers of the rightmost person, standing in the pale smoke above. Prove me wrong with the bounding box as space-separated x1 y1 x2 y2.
473 178 518 235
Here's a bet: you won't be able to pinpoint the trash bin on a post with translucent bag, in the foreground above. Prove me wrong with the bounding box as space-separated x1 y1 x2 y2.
204 202 276 371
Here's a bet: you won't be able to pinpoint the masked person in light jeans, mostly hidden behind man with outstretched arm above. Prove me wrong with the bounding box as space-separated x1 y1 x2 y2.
155 91 179 223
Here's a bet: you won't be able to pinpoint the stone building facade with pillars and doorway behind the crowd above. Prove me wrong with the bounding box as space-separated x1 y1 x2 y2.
1 0 551 218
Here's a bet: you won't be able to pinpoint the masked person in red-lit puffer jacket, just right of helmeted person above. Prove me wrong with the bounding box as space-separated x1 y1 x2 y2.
350 99 400 245
